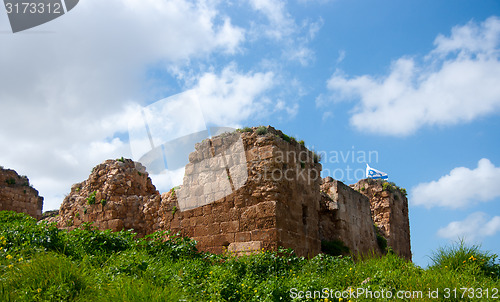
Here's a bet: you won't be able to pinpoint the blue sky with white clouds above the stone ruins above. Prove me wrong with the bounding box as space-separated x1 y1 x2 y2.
0 0 500 266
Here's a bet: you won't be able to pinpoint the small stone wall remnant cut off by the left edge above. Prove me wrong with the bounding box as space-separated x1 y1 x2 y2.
0 168 43 219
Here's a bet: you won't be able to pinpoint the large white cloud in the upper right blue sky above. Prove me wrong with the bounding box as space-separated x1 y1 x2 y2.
318 17 500 136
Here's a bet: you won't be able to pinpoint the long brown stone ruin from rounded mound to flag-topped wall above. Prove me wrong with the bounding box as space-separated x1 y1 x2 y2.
49 126 411 259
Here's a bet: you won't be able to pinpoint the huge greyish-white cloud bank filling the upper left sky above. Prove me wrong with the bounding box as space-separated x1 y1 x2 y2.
0 0 245 209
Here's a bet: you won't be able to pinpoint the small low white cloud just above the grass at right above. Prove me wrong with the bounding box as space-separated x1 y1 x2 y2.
437 212 500 242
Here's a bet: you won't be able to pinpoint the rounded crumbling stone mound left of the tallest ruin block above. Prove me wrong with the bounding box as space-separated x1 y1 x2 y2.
57 159 161 235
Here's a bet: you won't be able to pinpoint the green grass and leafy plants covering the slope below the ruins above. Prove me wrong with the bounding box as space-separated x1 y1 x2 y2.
0 212 500 301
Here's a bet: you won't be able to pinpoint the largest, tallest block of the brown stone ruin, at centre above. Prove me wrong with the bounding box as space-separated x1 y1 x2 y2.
152 127 321 256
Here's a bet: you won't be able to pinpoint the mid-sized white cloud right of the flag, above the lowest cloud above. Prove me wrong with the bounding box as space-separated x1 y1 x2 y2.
410 158 500 209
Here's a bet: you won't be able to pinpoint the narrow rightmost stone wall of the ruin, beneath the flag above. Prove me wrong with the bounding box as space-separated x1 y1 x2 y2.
353 179 411 260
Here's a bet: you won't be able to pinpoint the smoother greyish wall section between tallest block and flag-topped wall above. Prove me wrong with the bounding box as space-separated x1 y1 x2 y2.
319 177 380 254
